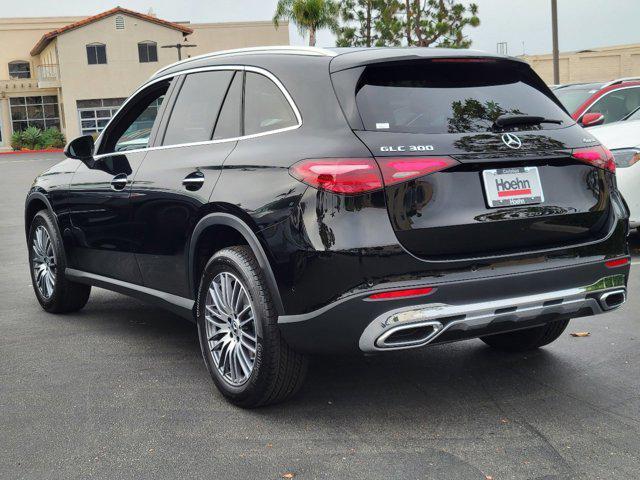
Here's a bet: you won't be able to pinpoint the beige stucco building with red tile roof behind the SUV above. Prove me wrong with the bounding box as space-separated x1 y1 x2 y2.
0 7 289 148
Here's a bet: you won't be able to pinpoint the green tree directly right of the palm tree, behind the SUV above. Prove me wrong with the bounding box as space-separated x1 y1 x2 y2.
336 0 404 47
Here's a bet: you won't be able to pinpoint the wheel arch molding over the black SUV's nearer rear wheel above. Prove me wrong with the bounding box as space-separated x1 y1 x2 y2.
187 212 284 315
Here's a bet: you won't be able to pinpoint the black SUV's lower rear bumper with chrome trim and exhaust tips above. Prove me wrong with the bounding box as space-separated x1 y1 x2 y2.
279 262 629 353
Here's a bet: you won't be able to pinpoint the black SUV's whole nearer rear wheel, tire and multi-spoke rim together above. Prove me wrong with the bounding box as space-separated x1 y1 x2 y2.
196 246 307 408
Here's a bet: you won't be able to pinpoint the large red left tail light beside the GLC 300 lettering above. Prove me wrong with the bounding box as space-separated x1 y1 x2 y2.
289 157 458 195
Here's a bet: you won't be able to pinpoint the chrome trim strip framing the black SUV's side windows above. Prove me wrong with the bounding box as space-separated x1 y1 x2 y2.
94 65 302 159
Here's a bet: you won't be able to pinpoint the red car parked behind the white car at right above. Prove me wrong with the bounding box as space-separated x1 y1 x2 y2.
553 78 640 127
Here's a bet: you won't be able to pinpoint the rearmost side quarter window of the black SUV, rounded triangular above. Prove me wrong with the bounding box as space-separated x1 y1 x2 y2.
244 72 298 135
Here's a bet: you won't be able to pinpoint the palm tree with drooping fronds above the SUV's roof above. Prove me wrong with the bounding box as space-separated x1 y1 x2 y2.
273 0 339 47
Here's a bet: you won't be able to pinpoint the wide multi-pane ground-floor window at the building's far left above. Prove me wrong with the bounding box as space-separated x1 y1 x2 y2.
9 95 60 132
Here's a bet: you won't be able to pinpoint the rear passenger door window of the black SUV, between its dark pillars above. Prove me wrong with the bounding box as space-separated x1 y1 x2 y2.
162 71 234 145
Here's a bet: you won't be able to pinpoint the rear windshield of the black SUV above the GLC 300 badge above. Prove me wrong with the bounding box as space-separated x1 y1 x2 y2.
348 59 573 133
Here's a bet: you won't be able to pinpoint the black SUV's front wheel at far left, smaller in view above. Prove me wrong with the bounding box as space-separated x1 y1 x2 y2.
28 210 91 313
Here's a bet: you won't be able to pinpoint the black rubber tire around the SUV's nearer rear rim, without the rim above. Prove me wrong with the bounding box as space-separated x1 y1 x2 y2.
196 246 308 408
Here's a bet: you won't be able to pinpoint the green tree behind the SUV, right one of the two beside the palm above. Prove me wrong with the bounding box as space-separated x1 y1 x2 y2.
404 0 480 48
